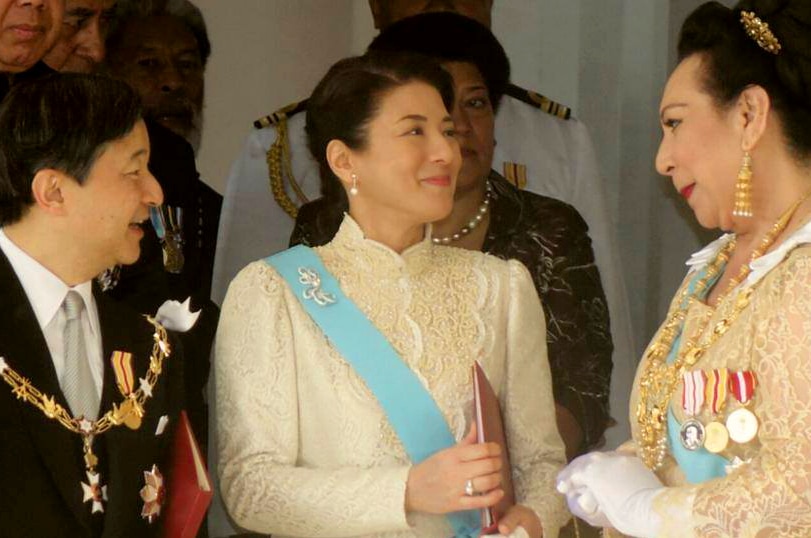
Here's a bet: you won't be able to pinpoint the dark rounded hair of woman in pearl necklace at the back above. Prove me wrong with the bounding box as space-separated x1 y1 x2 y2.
368 12 510 109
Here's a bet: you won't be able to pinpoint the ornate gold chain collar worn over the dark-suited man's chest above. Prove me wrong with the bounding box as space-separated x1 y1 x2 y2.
0 316 171 436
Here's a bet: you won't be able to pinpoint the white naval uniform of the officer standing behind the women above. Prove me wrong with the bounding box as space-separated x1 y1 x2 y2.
212 91 638 536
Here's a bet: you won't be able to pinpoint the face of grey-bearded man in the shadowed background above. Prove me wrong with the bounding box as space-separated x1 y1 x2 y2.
107 15 203 149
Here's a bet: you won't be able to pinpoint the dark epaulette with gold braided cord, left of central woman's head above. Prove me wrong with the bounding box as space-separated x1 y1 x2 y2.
253 99 308 219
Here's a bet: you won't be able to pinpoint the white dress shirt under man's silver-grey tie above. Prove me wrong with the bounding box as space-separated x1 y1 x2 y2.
0 228 104 398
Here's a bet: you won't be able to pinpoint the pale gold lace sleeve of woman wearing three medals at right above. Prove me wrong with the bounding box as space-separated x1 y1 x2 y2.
656 254 811 538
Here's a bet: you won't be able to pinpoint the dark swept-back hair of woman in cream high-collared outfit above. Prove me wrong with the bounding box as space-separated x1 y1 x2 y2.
305 53 453 207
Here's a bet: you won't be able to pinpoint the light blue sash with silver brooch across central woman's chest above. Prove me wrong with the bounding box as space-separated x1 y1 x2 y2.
265 245 481 538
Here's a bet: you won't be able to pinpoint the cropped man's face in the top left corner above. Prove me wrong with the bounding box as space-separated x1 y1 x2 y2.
0 0 65 73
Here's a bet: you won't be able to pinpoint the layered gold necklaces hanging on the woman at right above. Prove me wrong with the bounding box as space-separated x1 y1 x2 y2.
636 192 811 471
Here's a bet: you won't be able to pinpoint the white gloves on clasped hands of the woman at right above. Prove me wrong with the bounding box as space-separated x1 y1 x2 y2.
558 452 664 538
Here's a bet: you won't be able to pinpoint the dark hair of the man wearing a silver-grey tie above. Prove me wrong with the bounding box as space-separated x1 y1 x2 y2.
0 74 141 226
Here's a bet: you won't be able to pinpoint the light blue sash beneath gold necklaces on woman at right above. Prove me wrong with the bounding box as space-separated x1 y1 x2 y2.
667 269 729 484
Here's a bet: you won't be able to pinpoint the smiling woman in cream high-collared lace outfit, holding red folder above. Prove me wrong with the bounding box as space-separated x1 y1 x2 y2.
215 55 566 538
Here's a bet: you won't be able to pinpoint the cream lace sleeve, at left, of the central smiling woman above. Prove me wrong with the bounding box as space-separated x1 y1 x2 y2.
215 262 409 537
